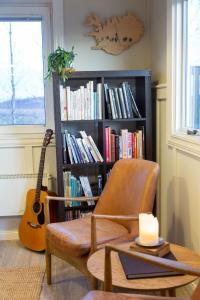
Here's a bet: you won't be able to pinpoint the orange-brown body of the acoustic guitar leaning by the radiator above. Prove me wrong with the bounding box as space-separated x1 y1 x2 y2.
19 189 49 251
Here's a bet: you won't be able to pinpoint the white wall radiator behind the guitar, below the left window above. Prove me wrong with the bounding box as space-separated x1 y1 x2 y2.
0 173 52 216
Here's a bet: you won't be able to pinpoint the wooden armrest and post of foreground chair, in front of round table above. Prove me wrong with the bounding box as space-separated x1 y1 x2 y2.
104 245 200 291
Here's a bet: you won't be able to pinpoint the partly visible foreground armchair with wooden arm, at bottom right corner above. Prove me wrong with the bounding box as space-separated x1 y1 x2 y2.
82 245 200 300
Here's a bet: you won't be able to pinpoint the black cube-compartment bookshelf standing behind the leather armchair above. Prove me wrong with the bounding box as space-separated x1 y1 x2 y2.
53 70 155 220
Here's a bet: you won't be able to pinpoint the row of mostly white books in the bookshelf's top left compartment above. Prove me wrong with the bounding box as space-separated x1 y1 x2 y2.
60 81 102 121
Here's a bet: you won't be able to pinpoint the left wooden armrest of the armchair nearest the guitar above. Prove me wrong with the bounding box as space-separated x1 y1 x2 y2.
45 196 99 225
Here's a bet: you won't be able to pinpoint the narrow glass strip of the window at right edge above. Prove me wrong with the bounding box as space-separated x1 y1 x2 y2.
184 0 200 129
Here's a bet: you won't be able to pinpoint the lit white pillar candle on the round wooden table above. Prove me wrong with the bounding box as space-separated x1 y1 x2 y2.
139 213 159 246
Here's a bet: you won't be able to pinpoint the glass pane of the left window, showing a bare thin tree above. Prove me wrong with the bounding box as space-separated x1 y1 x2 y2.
0 18 45 125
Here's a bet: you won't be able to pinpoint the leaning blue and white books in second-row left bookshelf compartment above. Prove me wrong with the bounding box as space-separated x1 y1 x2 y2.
63 130 103 164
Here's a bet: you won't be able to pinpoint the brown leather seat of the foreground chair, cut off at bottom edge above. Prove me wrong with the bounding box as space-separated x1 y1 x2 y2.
82 291 190 300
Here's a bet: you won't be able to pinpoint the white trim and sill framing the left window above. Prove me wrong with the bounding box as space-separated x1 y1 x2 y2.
0 0 64 147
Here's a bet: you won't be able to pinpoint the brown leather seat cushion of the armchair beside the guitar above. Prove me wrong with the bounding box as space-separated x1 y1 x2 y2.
46 217 130 256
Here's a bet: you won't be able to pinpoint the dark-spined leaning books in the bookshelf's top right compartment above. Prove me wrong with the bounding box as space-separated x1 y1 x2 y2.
104 81 142 119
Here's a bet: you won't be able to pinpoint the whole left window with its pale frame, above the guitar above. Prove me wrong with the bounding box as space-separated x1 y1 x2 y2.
0 4 53 133
